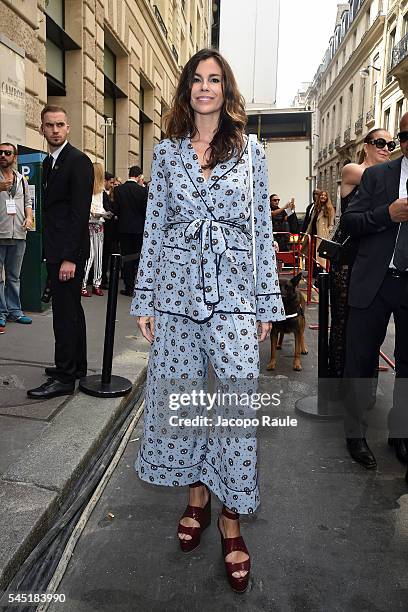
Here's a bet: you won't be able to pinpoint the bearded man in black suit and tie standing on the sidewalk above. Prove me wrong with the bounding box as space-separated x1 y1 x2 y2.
27 106 94 399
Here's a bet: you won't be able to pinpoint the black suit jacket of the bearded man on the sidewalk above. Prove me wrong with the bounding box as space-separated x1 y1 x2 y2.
43 142 94 263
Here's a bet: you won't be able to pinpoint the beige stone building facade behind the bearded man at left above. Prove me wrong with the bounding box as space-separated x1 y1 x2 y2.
0 0 212 176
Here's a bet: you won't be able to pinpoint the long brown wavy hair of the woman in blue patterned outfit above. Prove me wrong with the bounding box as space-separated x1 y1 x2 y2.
165 49 247 168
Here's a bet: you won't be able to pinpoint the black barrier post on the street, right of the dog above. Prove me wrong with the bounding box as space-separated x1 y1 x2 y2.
295 272 343 421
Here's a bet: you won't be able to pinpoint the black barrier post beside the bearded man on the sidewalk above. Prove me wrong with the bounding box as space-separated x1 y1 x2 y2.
79 255 132 397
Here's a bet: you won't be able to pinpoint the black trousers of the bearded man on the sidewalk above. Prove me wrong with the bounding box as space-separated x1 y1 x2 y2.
47 262 88 383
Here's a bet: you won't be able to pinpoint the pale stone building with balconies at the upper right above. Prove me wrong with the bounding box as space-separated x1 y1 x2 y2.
305 0 408 200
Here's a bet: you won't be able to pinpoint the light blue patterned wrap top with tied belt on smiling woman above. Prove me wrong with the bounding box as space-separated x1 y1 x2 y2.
131 138 284 322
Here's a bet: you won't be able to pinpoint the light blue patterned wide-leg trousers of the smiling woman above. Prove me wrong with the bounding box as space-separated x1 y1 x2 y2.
135 314 259 514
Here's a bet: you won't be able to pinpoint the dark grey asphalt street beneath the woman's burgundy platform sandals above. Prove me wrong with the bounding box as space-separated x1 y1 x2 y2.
23 296 408 612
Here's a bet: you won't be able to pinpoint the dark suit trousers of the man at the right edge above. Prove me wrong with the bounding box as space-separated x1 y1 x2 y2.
344 274 408 438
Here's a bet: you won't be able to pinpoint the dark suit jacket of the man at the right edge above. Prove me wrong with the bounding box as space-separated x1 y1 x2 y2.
341 158 402 308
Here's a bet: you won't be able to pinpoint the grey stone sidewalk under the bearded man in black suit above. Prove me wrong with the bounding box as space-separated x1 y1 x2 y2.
0 292 147 590
